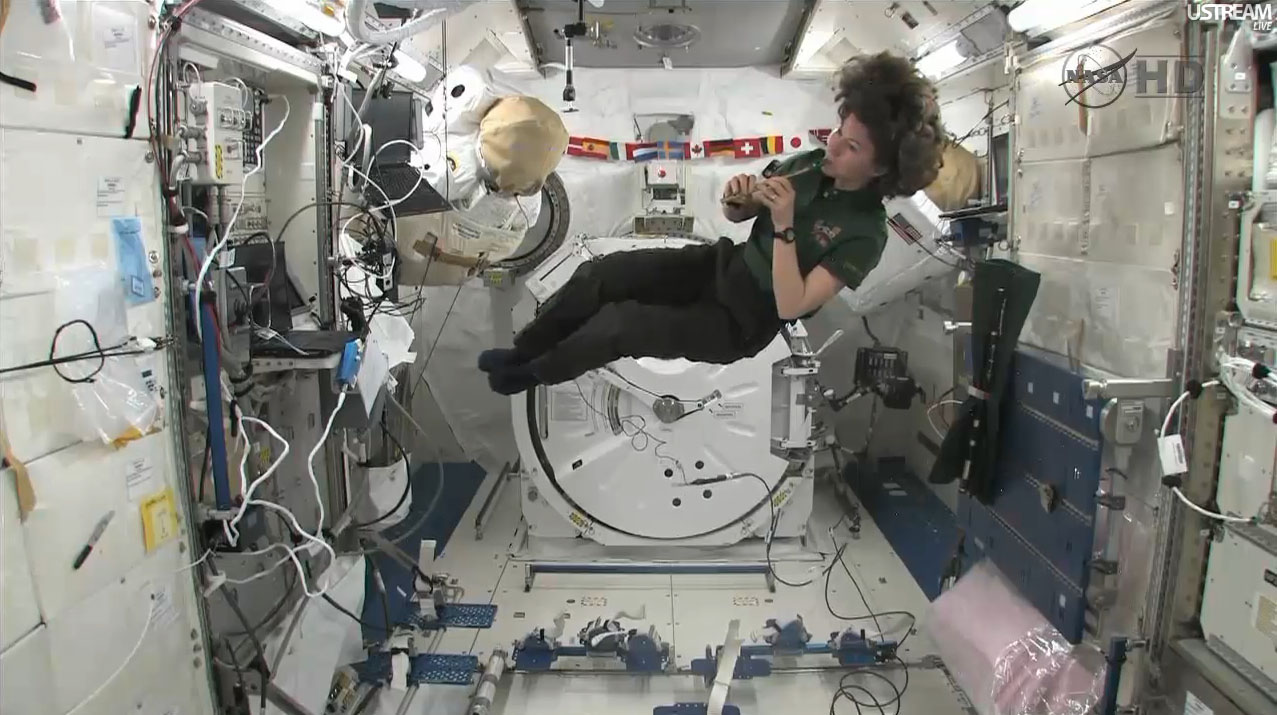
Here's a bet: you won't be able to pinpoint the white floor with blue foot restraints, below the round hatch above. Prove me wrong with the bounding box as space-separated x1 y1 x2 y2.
393 475 967 715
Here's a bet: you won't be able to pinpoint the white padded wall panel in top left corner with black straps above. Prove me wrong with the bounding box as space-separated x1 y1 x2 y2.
0 0 153 138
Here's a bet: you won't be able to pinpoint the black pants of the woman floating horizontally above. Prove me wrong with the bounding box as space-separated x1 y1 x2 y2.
515 239 783 384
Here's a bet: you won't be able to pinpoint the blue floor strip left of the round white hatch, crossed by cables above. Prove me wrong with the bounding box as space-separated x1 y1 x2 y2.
360 462 487 642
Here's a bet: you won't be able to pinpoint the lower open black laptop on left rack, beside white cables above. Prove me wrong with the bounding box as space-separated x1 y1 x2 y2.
234 241 358 359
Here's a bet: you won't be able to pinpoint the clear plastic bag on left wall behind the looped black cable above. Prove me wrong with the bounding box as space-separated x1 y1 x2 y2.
54 268 160 444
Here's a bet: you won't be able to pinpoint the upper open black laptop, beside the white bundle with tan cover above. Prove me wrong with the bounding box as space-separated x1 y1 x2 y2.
354 91 450 216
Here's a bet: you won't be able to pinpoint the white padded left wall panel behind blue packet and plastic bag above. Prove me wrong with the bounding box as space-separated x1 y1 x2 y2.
0 129 166 461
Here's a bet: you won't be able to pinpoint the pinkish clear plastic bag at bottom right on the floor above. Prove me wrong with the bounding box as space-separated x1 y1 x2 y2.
927 561 1105 715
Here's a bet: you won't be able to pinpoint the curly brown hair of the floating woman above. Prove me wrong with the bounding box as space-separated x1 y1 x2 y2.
836 52 948 198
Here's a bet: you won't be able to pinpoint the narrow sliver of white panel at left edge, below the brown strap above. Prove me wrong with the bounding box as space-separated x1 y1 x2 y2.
0 470 40 652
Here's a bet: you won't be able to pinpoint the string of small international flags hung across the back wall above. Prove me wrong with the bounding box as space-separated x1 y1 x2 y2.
567 129 833 161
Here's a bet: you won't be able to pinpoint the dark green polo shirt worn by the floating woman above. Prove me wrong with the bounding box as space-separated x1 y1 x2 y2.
744 149 886 306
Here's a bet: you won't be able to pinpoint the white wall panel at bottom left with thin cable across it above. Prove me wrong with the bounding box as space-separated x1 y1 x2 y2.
47 544 211 715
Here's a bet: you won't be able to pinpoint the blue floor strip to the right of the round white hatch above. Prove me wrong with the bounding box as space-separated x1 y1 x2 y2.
843 458 960 600
